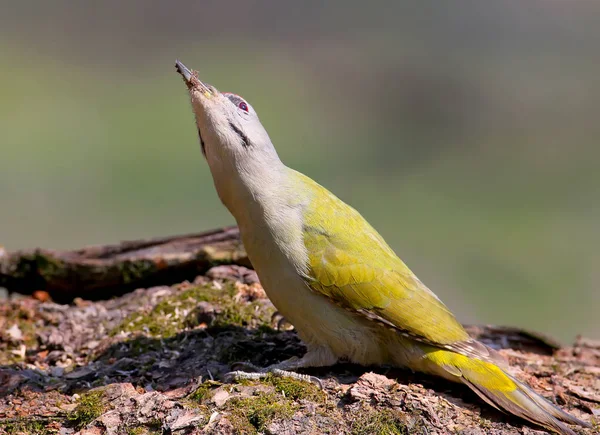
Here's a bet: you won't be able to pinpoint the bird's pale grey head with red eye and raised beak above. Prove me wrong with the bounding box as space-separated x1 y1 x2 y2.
175 61 276 169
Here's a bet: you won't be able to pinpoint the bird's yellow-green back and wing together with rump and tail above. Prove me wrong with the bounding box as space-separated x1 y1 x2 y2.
292 172 589 435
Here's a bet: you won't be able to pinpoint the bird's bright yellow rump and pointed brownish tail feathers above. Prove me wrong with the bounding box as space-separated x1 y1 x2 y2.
425 350 592 435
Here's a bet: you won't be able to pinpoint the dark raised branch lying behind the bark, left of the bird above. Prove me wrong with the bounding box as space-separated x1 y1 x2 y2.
0 227 250 301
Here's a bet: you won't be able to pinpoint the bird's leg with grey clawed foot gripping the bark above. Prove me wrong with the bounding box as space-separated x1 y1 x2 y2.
225 347 338 389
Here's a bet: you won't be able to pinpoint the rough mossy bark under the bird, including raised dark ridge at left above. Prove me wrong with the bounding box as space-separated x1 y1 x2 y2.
0 232 600 435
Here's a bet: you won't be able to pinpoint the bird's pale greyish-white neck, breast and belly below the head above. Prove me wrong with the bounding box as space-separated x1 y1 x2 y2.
211 160 390 365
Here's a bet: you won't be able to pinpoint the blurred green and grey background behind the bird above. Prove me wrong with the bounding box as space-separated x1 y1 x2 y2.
0 0 600 341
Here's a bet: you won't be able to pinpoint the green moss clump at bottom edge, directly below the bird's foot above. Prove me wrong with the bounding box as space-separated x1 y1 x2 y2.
227 393 298 434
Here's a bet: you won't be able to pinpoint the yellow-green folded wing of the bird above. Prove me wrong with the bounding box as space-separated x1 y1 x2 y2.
298 174 470 353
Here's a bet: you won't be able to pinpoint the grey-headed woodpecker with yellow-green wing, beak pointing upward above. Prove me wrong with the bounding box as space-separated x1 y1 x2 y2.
175 61 591 435
